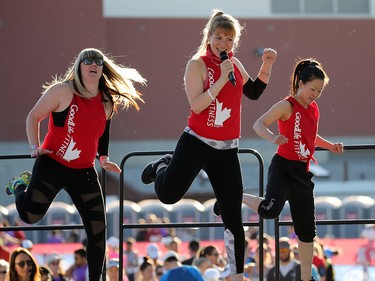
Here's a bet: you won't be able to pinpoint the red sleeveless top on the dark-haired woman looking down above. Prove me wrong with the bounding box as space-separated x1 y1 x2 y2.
277 96 319 161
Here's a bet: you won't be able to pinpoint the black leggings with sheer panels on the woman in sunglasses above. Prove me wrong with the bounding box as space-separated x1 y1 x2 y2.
15 155 106 281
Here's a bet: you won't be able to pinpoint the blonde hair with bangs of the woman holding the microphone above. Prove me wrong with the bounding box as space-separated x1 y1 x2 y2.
193 9 244 59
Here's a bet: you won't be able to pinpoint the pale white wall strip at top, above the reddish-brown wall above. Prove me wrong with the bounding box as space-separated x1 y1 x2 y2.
103 0 375 18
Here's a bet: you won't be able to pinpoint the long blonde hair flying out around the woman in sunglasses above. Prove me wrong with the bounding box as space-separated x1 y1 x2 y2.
43 48 146 112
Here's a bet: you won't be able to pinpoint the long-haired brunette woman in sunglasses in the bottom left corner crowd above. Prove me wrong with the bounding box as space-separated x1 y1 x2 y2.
7 247 41 281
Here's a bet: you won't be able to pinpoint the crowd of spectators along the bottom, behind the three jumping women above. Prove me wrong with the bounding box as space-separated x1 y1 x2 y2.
0 229 344 281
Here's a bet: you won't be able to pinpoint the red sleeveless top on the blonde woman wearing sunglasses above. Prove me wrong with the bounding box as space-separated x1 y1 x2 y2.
42 93 106 169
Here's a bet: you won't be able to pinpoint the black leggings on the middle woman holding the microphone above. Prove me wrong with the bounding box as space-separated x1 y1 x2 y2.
155 133 245 273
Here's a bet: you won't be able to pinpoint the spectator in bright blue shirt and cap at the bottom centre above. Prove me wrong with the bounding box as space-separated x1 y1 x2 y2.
160 251 204 281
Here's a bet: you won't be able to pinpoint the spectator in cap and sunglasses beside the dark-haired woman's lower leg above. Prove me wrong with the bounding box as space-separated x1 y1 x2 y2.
267 237 301 281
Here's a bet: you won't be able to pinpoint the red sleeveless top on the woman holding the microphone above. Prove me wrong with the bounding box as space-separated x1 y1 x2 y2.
188 46 243 140
